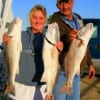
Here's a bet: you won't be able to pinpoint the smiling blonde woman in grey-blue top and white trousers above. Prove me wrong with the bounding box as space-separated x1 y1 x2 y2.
3 5 63 100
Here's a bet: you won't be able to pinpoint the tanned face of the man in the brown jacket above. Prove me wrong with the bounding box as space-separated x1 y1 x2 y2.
57 0 74 16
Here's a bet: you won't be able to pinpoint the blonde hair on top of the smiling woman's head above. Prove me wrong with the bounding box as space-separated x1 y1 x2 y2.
29 5 47 19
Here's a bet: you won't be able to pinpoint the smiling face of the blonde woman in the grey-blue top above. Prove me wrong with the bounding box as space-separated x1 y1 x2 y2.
30 10 46 32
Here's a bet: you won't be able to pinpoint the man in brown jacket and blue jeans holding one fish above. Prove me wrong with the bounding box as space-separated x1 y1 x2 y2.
50 0 95 100
